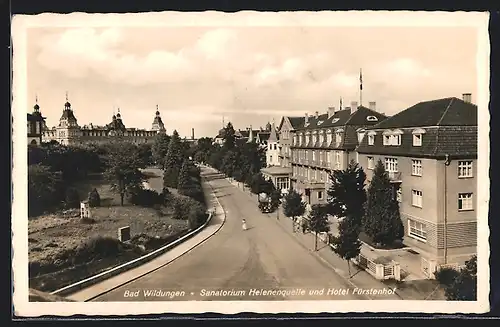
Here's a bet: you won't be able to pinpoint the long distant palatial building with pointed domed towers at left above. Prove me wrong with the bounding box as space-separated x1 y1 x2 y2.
28 95 166 145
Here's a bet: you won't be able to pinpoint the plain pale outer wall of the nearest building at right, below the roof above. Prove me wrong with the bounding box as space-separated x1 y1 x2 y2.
358 154 477 263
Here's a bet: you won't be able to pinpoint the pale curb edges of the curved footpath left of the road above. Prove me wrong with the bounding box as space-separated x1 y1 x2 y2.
50 172 226 301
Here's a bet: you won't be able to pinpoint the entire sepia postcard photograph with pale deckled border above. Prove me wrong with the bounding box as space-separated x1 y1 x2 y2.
12 11 490 317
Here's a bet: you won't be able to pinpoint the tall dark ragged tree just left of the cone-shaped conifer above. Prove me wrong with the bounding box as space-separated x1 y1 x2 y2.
327 160 366 230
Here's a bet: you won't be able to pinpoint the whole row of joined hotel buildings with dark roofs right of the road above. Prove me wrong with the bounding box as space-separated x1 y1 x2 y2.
275 94 478 272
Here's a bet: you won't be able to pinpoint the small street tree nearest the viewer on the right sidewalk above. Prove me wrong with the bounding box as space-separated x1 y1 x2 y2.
330 214 361 278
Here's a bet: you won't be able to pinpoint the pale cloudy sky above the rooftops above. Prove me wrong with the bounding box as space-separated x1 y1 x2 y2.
25 17 478 137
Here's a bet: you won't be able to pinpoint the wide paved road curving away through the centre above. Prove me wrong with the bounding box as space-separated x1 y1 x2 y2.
94 170 364 301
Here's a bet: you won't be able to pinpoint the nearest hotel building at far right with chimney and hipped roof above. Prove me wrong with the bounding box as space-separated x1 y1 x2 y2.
357 94 477 276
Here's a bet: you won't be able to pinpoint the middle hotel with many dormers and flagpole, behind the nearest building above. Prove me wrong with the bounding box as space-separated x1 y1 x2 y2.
290 102 387 205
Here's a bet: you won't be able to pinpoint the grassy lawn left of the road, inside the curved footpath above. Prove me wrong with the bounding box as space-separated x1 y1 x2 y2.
28 179 188 291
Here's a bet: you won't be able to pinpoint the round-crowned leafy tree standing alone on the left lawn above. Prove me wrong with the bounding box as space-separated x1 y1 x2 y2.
104 142 145 206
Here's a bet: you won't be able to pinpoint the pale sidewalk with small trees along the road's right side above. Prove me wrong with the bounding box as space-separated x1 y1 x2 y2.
226 178 402 300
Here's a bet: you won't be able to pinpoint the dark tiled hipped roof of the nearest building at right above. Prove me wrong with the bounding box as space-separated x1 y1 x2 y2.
357 98 478 158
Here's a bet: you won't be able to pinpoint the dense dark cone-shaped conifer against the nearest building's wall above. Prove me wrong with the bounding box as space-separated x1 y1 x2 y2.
363 160 404 245
